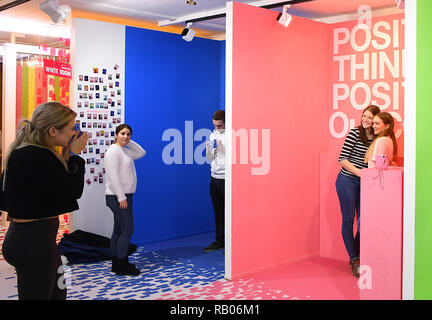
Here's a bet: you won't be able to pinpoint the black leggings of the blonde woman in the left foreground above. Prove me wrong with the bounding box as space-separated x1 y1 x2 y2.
3 218 67 300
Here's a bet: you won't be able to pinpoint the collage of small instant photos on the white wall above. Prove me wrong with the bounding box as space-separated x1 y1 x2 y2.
76 64 123 185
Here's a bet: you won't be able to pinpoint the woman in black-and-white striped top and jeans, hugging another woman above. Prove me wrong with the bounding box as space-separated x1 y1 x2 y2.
336 105 380 278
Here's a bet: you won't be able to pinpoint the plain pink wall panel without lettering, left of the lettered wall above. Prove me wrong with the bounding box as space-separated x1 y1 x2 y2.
231 2 331 278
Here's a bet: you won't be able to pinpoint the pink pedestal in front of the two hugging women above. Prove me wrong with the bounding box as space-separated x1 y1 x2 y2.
358 168 403 300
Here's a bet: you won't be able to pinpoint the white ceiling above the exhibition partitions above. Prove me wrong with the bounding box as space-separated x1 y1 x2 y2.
0 0 402 42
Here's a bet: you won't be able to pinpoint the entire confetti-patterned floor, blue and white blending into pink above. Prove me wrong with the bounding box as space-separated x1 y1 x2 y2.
0 225 359 300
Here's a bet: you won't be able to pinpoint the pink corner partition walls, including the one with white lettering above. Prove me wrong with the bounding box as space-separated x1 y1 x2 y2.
226 2 405 279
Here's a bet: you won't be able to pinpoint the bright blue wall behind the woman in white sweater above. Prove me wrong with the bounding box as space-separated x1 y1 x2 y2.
125 27 225 245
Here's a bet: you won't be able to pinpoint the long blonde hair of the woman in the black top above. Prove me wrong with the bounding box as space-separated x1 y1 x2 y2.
3 102 76 188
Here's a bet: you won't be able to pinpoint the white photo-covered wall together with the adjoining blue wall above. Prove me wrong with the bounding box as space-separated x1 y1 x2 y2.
72 19 224 247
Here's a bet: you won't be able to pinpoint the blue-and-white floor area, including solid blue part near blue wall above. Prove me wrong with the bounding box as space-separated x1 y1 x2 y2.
0 228 224 300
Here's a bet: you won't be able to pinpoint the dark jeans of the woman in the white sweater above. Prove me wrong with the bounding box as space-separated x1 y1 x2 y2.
105 194 134 259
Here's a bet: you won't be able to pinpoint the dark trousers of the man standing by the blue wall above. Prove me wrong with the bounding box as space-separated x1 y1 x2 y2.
210 177 225 245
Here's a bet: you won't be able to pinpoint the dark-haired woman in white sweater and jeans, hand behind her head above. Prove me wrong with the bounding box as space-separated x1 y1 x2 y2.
105 124 146 275
